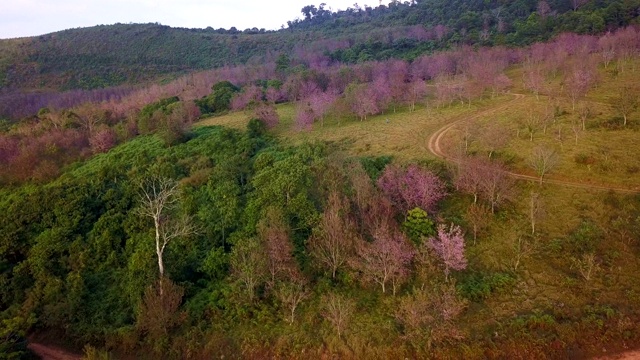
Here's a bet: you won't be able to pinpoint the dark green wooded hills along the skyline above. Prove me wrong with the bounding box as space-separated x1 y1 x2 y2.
0 0 640 90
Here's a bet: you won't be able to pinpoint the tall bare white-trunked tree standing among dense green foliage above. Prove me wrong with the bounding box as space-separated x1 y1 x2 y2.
138 176 196 288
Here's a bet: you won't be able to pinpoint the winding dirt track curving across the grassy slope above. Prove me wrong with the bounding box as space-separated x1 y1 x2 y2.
427 94 640 194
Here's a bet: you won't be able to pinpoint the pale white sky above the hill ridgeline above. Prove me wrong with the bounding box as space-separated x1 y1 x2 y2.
0 0 388 39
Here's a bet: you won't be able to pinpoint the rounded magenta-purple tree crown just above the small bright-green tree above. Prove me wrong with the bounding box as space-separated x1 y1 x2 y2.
378 165 446 213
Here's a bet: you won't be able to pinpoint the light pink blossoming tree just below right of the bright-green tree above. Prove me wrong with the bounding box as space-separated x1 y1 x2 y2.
428 223 467 280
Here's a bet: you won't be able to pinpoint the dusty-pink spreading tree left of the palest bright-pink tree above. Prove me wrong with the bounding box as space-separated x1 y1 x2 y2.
355 227 414 295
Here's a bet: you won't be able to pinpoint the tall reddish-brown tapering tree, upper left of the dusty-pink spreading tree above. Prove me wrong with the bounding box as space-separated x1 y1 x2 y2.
309 190 356 278
